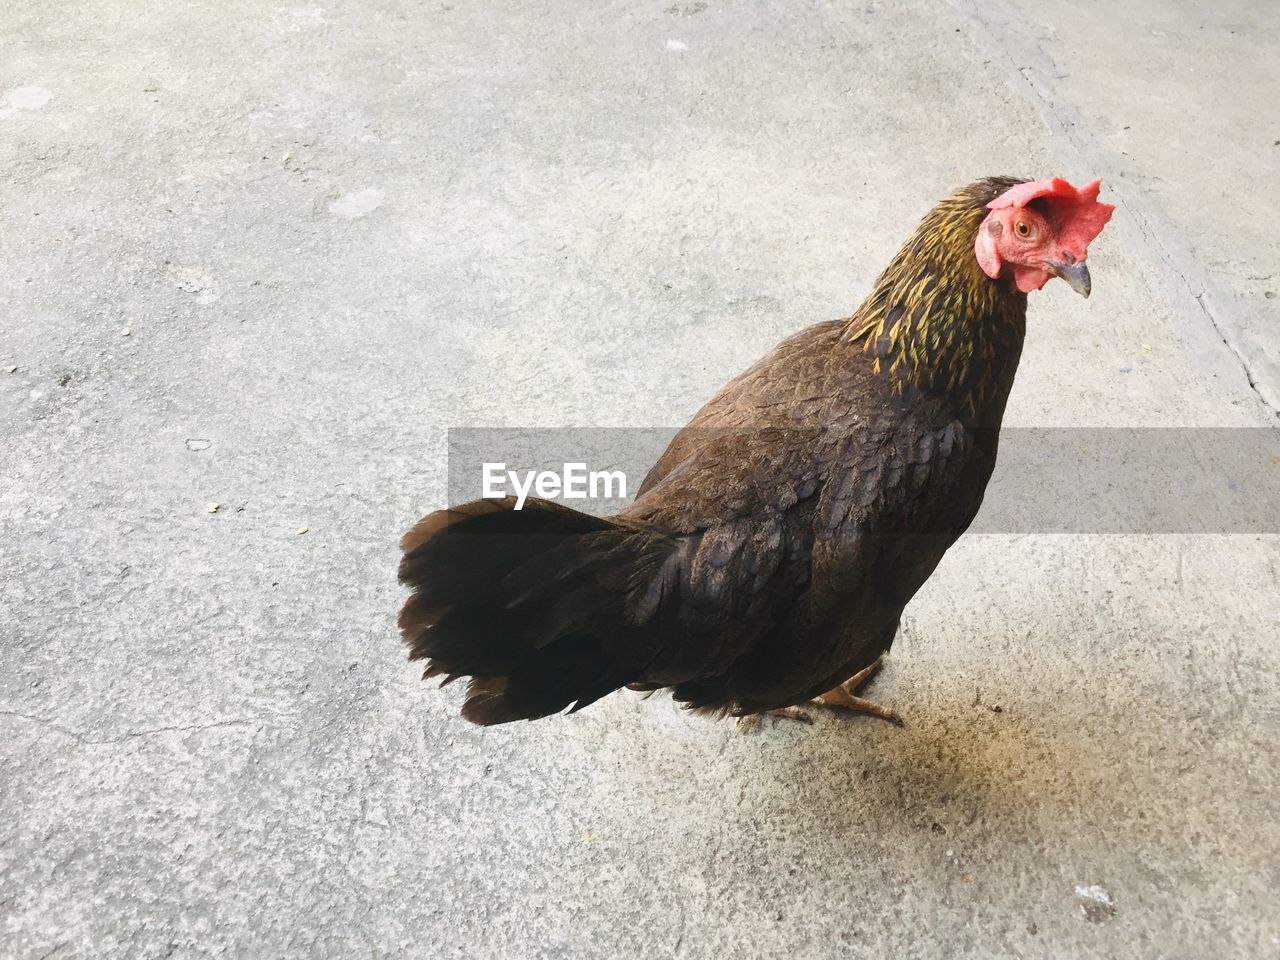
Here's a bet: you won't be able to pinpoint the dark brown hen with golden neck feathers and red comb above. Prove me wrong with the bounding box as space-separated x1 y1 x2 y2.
399 177 1112 724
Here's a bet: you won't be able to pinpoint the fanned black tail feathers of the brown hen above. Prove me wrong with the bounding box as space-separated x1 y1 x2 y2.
399 497 676 724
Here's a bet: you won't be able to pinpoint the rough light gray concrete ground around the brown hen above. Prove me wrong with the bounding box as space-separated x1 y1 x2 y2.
0 0 1280 960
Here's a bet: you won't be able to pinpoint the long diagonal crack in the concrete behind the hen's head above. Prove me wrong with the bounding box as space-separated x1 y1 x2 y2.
948 0 1280 416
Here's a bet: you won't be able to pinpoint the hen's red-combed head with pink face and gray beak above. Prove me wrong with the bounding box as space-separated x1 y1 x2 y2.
974 177 1115 297
